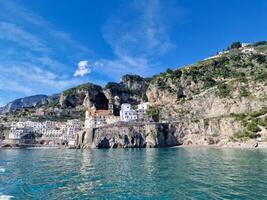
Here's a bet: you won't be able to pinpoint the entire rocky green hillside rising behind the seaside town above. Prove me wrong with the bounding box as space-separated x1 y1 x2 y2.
2 42 267 144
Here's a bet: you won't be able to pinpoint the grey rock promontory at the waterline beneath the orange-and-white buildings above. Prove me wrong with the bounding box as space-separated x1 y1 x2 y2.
77 123 179 148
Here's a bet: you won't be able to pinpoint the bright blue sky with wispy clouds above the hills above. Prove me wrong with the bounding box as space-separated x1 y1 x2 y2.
0 0 267 105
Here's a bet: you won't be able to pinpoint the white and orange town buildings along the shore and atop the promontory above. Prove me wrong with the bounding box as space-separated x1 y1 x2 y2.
9 97 150 144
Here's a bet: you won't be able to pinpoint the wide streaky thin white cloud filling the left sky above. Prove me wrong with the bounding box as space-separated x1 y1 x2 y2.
0 0 91 104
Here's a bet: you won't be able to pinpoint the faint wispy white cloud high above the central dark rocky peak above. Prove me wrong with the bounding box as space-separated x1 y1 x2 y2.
93 0 179 80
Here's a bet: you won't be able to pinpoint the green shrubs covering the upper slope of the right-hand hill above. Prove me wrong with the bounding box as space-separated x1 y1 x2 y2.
151 42 267 97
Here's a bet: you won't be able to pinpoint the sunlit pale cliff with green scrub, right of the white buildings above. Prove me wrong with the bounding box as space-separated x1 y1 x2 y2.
146 43 267 144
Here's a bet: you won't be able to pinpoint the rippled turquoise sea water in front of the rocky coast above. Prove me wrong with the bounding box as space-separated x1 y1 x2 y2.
0 148 267 200
